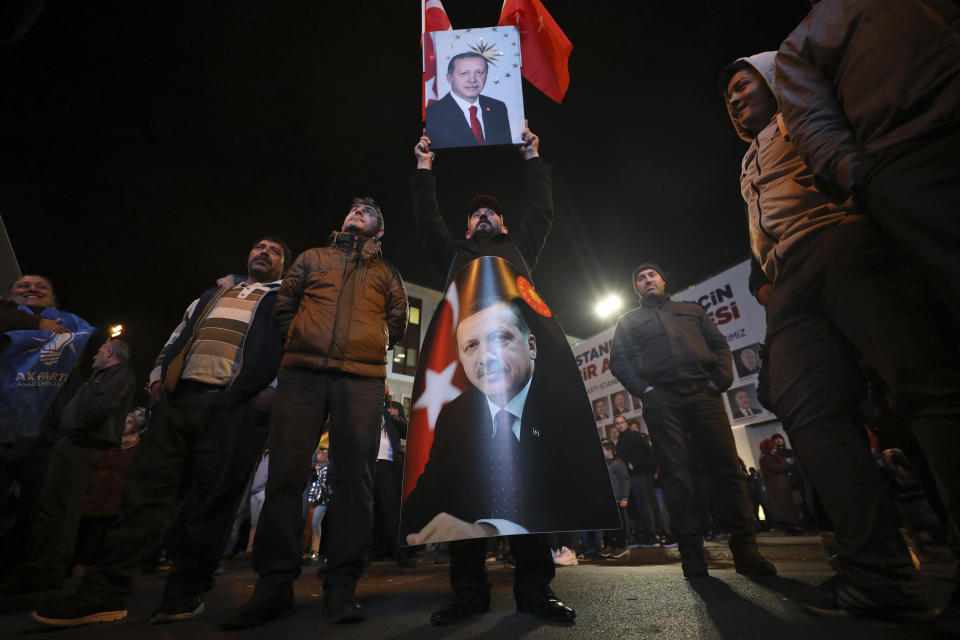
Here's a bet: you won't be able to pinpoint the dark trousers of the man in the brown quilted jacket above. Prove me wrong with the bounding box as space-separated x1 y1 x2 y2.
253 367 384 593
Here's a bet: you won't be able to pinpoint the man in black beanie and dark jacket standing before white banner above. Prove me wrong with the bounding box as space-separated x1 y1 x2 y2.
610 263 776 578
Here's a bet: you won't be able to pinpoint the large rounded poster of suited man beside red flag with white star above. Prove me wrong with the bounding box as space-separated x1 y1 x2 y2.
400 256 621 543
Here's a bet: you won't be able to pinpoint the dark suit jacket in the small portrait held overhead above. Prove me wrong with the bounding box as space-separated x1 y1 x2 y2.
427 92 513 149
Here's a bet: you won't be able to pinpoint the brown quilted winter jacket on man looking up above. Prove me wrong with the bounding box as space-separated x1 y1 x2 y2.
276 232 407 378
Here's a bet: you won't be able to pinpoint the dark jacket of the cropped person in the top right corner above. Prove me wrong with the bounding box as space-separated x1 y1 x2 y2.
775 0 960 200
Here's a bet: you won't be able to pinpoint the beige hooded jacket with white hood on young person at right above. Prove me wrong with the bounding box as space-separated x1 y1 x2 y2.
723 51 853 294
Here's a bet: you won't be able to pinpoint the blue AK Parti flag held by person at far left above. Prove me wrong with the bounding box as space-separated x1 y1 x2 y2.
0 306 97 442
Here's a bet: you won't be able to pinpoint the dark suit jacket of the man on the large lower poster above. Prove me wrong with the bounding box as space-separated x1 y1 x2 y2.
400 370 620 535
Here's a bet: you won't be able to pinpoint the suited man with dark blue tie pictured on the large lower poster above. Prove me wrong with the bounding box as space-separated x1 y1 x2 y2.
401 298 616 542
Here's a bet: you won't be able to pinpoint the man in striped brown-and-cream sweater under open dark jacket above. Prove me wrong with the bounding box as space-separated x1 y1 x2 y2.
31 236 290 626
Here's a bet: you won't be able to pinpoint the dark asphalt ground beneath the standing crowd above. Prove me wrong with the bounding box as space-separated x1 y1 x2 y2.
0 550 954 640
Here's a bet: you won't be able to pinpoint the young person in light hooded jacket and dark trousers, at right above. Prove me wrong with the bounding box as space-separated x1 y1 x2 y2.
720 51 960 620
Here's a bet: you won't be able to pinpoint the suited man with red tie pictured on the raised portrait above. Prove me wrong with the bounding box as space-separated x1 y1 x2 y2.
426 51 512 149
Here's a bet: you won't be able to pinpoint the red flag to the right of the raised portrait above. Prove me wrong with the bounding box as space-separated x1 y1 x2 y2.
497 0 573 102
